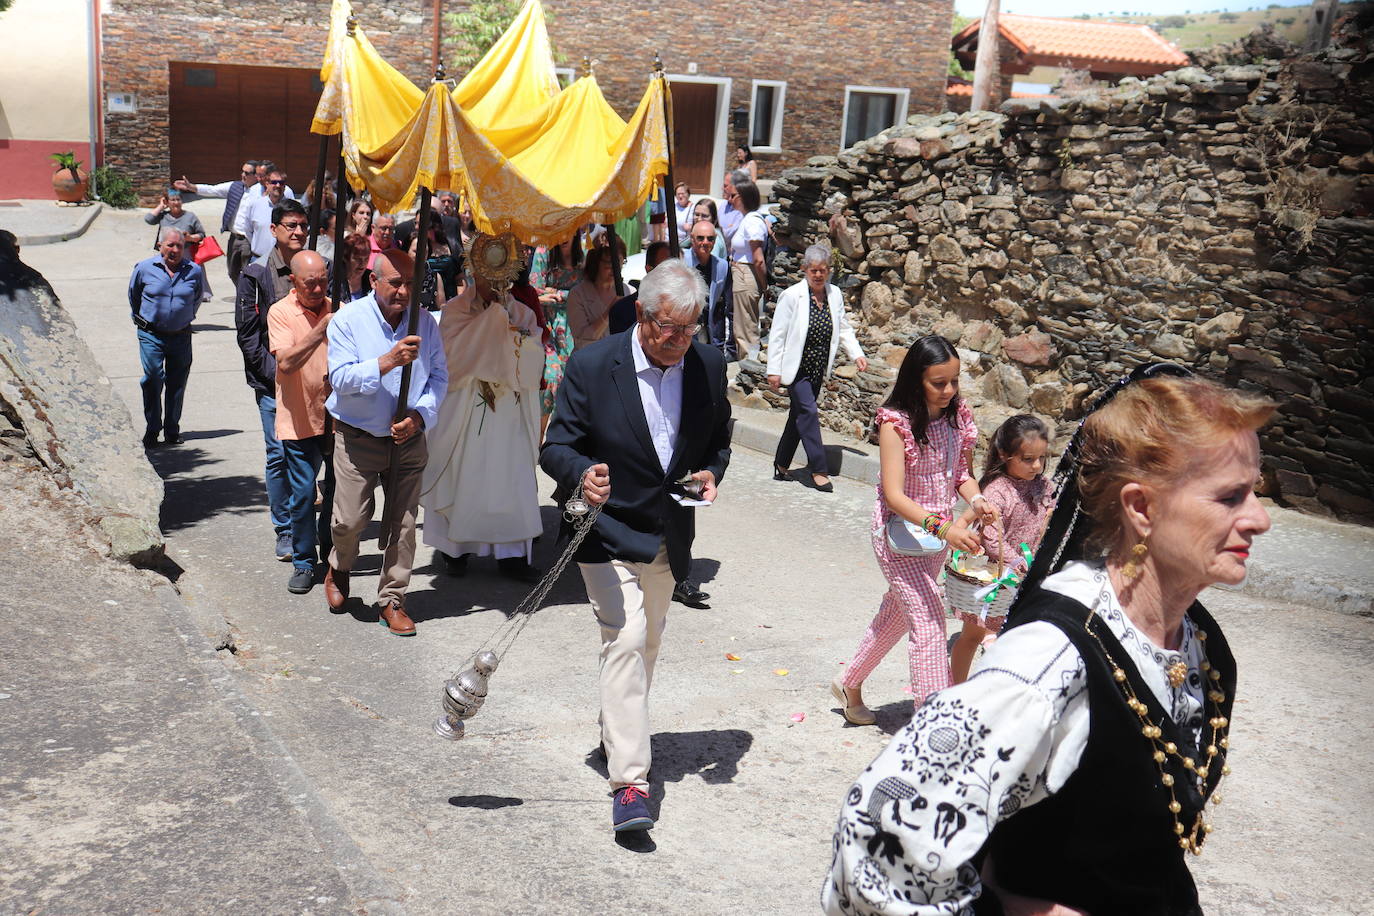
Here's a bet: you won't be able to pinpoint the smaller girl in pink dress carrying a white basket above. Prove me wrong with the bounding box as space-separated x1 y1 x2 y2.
949 413 1052 684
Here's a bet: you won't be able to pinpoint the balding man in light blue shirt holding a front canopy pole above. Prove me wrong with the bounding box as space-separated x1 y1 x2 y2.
324 249 448 636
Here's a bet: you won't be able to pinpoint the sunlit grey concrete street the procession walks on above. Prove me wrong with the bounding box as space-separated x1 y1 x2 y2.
10 202 1374 916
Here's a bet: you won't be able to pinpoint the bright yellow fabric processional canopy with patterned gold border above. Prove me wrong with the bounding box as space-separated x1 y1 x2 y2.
311 0 668 244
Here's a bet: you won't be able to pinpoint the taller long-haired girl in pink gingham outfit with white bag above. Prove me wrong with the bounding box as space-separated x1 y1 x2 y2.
830 335 998 725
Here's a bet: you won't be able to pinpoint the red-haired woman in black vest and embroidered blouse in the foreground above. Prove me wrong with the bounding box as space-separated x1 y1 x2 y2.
822 365 1274 916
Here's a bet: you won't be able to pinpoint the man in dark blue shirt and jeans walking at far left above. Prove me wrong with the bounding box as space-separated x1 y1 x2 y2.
129 229 205 449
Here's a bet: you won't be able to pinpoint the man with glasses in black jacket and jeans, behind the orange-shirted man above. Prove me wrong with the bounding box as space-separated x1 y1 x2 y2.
234 198 309 563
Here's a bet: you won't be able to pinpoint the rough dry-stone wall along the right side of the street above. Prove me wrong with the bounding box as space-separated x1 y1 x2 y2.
758 26 1374 522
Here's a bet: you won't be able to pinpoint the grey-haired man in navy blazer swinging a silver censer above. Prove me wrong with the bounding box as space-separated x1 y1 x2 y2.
540 261 730 831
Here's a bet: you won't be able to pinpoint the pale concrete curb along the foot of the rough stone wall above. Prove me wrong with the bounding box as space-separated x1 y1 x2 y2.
731 417 1374 617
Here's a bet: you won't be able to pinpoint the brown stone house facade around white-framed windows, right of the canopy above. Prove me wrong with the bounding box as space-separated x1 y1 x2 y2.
545 0 954 177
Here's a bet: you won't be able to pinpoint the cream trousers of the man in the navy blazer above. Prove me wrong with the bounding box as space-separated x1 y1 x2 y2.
577 547 673 791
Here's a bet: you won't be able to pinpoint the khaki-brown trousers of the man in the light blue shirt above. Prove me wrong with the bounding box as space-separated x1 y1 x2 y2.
330 423 429 604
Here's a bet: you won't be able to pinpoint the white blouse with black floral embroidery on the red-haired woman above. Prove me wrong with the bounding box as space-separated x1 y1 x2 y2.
820 563 1204 916
